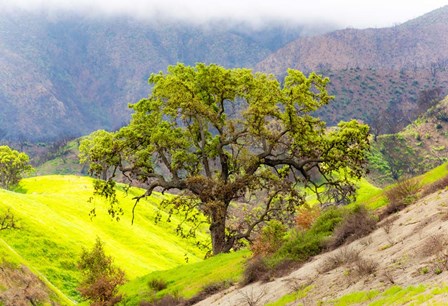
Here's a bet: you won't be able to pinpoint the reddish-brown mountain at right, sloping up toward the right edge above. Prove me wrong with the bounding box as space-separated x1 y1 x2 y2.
257 6 448 132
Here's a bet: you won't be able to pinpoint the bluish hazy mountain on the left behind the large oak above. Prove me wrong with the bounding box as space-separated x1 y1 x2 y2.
0 13 312 142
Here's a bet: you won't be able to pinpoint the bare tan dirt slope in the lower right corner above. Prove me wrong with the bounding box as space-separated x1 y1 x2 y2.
197 190 448 305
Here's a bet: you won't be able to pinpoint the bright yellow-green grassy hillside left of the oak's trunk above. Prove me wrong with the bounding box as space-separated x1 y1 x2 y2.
0 176 206 300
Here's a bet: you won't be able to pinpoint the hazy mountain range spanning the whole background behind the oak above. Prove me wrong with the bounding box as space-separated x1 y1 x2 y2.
0 7 448 142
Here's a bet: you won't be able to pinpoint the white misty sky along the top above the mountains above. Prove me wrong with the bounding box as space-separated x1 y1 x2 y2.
0 0 448 28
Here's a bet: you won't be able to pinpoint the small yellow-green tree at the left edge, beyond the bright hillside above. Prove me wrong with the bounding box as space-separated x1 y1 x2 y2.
0 146 33 189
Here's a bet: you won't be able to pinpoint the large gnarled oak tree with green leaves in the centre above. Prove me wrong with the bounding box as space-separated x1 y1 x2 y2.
81 63 369 254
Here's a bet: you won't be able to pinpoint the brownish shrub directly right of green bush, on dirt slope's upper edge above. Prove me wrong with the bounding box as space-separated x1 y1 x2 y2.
327 206 376 249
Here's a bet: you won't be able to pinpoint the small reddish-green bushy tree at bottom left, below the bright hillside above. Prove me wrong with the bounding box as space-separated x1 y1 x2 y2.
78 238 126 306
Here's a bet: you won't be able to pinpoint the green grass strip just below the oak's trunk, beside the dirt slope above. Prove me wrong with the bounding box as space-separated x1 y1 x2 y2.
121 250 250 305
